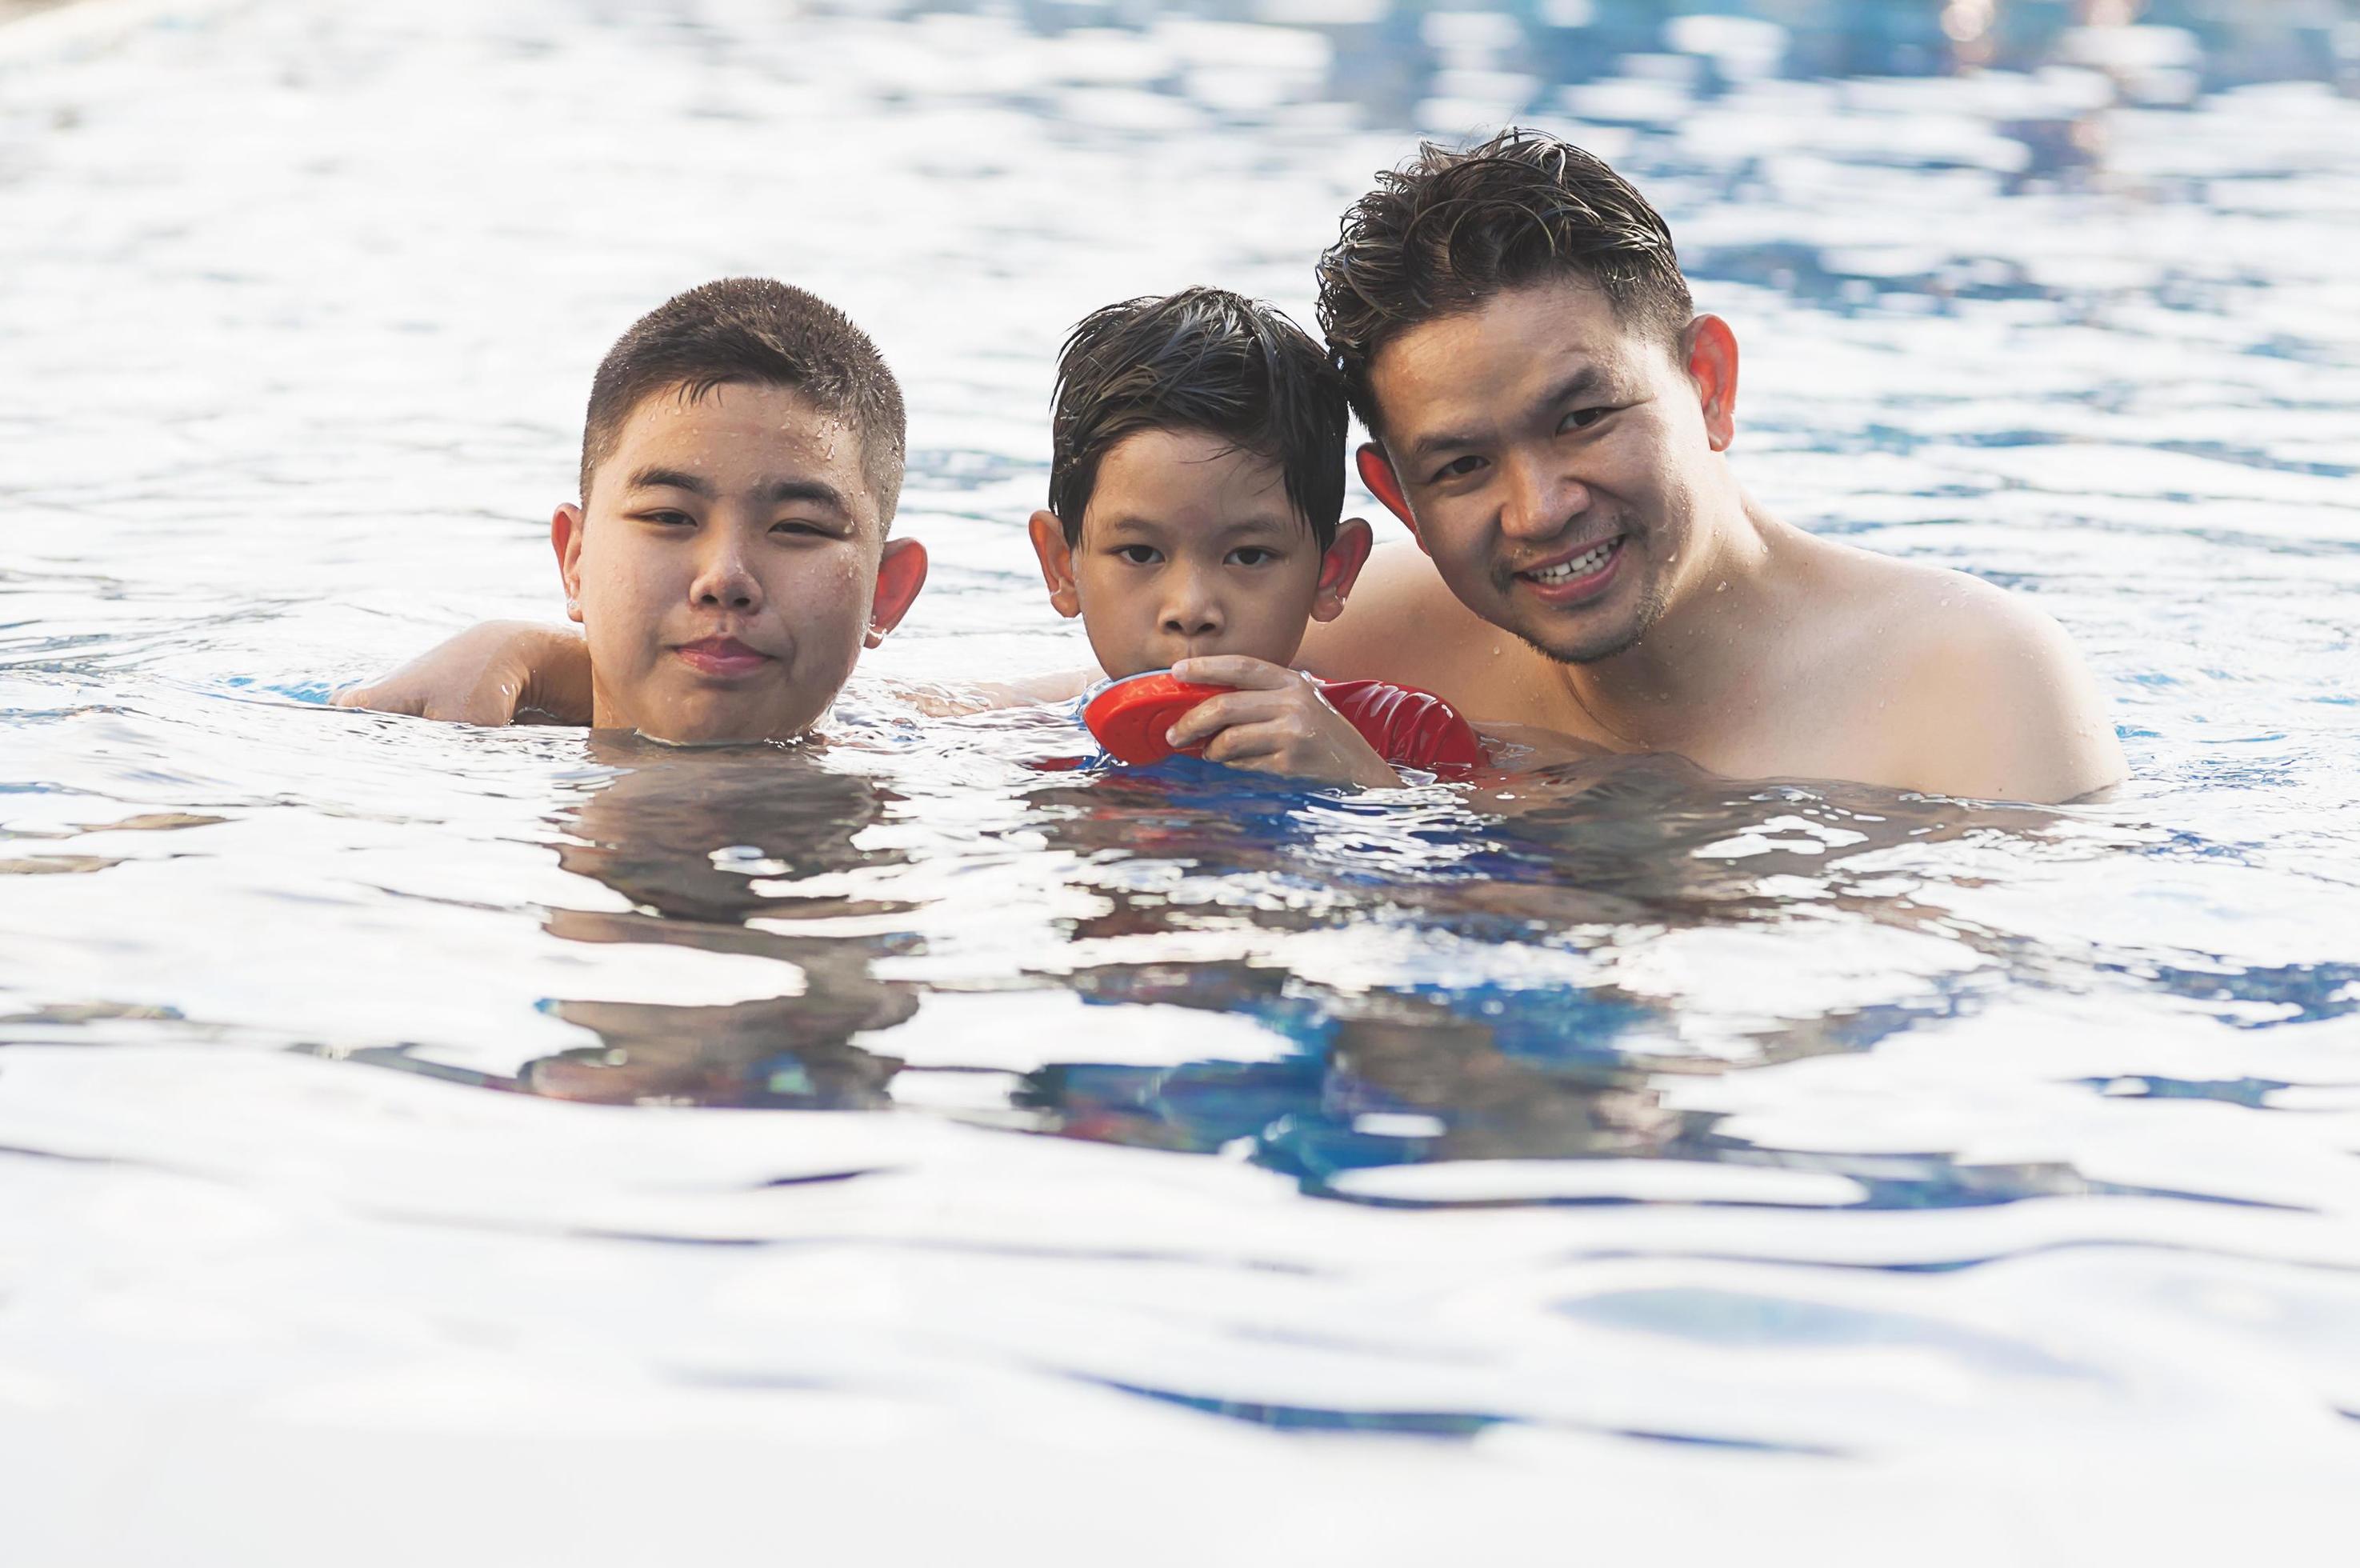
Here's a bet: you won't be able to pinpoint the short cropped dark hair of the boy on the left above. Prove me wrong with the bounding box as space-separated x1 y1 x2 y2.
581 278 909 522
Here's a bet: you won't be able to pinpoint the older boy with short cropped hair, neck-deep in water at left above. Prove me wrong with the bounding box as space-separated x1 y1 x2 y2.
338 278 925 742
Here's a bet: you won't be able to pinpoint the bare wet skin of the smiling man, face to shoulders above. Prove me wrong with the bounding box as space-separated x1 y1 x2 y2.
1302 278 2124 801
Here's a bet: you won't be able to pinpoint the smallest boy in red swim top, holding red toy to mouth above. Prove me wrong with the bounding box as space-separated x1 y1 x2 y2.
1031 288 1482 786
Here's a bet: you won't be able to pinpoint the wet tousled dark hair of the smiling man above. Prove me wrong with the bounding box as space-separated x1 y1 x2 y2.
1319 130 1694 439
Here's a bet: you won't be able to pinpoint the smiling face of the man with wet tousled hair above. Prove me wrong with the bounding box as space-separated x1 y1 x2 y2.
1364 278 1734 663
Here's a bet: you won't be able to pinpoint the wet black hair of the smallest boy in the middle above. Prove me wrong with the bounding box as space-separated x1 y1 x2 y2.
1048 288 1350 550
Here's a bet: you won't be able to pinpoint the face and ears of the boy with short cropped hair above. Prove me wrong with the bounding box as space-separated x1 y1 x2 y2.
550 382 925 742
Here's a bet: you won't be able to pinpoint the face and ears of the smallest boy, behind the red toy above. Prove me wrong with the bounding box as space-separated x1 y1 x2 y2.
1031 430 1369 675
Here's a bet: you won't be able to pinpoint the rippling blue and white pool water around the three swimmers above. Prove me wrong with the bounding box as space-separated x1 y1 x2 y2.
0 0 2360 1563
